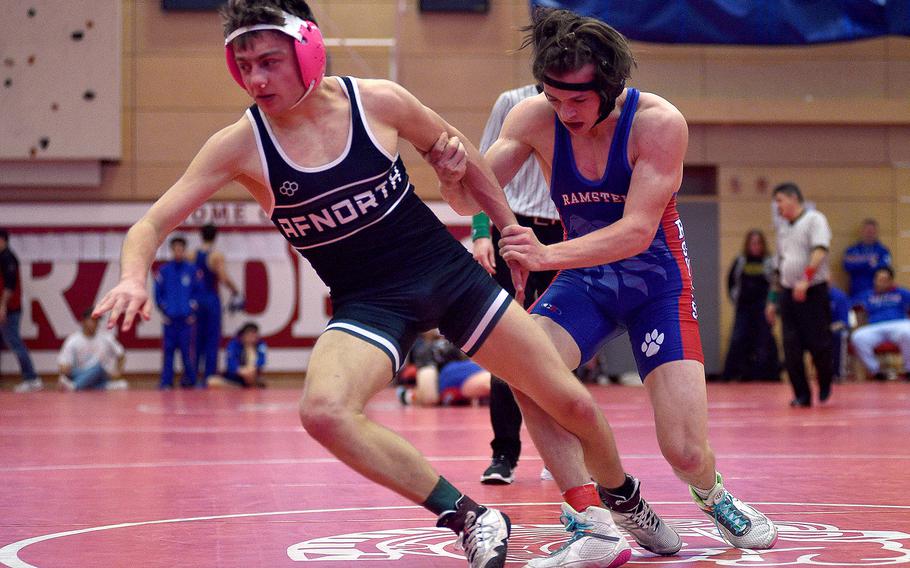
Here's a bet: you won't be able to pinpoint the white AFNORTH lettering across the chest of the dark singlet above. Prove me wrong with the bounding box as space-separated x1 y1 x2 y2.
275 164 406 238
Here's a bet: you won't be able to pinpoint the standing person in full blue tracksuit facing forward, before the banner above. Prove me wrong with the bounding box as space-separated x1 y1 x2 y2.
155 237 202 389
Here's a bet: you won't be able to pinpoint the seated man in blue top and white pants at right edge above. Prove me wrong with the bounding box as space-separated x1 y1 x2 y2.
850 267 910 380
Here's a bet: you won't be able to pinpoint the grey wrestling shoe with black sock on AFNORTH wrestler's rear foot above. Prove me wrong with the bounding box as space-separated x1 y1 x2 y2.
597 474 682 556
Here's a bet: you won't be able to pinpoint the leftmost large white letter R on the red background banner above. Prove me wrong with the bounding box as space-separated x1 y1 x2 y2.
19 261 79 339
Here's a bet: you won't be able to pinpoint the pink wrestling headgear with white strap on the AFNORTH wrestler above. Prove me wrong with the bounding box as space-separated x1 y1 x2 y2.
224 12 325 99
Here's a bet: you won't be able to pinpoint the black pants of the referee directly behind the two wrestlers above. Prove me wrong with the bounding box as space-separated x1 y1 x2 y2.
490 215 563 467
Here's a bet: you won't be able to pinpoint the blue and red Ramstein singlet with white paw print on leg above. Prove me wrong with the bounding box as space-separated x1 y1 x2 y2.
531 88 704 379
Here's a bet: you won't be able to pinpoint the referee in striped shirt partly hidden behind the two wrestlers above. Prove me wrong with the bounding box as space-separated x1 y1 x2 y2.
471 85 563 484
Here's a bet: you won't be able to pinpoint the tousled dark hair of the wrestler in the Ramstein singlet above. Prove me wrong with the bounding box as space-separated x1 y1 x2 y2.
521 8 635 99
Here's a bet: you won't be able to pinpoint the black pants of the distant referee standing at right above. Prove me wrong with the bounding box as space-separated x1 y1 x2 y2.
780 283 834 406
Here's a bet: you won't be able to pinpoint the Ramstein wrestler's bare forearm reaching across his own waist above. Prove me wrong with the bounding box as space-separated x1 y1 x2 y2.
544 219 654 270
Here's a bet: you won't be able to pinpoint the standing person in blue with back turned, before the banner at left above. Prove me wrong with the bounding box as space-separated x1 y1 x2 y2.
193 223 241 385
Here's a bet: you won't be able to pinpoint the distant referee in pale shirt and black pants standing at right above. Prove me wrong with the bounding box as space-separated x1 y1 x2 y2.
766 183 834 407
